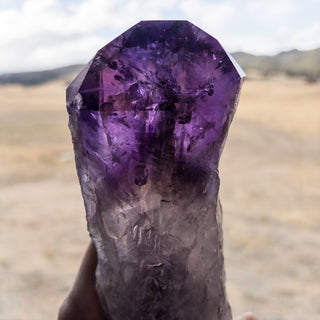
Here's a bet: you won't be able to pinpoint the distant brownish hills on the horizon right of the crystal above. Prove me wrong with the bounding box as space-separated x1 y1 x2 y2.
232 48 320 82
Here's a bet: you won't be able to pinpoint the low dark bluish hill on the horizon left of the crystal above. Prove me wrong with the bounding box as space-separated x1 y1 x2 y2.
0 64 83 86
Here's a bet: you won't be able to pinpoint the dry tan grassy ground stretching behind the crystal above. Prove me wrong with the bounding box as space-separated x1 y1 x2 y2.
0 78 320 320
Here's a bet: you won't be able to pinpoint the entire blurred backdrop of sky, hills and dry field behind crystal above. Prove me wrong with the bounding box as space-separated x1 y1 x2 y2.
0 0 320 320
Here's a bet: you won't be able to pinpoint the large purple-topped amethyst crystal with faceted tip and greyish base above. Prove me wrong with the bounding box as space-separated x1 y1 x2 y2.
67 21 244 320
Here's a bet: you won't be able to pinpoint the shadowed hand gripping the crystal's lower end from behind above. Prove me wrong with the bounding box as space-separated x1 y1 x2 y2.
58 241 258 320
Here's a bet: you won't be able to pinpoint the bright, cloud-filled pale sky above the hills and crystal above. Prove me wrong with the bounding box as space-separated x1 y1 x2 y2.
0 0 320 73
